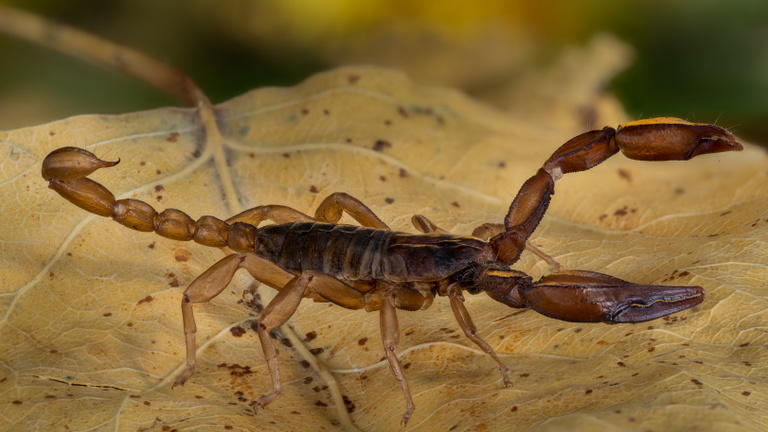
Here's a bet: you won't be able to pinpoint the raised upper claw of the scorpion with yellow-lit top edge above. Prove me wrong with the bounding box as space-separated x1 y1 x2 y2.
614 117 743 160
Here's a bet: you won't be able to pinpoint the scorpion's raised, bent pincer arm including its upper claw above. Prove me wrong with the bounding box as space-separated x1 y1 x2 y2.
490 117 742 265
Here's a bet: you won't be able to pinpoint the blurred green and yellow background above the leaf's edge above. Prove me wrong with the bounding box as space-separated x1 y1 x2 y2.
0 0 768 145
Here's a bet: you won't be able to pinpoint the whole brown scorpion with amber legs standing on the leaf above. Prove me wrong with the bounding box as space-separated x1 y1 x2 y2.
42 118 742 423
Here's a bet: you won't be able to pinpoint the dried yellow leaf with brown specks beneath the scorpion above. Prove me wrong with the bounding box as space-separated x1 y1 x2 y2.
0 68 768 431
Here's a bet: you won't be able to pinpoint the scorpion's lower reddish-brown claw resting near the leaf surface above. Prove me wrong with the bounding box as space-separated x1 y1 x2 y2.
522 270 704 323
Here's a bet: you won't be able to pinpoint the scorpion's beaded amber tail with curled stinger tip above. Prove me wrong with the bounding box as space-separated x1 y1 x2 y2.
42 147 255 251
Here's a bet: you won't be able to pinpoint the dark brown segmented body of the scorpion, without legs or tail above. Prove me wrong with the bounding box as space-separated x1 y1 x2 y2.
255 222 494 283
